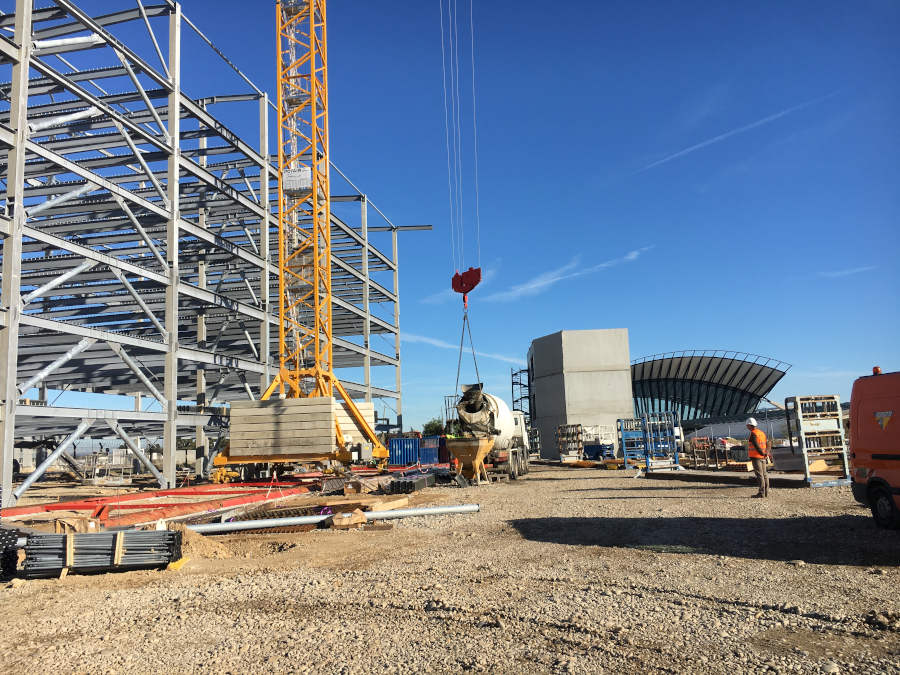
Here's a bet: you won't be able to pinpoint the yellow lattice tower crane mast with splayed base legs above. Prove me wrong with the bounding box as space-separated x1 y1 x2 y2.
262 0 388 460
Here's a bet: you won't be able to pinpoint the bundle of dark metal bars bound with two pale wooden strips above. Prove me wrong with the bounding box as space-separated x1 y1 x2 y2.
23 530 181 579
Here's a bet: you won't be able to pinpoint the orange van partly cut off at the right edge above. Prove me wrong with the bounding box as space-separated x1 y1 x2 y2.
850 367 900 529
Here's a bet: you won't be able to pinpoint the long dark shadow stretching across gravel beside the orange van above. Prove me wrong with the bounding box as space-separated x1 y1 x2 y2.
510 514 900 566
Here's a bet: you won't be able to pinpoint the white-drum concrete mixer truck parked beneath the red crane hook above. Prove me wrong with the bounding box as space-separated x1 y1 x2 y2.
448 384 529 480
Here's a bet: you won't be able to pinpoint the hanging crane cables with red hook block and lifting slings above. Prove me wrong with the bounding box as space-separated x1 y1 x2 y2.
438 0 482 391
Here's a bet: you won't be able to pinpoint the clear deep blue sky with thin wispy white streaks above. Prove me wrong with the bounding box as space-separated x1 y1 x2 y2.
47 0 900 426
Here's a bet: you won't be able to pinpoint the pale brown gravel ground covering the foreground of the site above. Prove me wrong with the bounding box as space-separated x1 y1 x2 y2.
0 466 900 673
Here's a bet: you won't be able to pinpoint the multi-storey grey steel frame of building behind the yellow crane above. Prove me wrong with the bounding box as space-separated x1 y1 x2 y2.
0 0 404 506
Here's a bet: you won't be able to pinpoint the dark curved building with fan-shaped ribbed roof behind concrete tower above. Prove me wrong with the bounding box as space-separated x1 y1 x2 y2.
631 350 791 420
